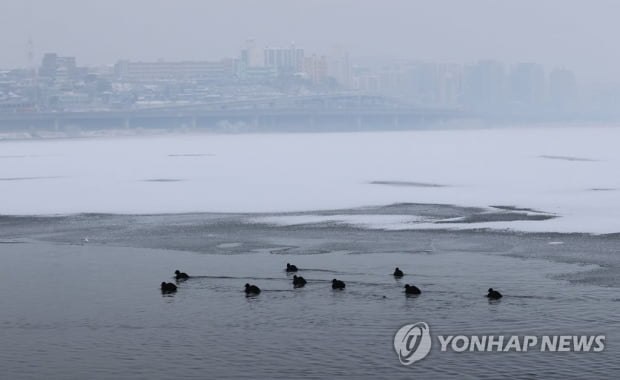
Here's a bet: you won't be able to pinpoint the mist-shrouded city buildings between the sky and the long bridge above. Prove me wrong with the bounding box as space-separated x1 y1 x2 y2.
0 40 592 117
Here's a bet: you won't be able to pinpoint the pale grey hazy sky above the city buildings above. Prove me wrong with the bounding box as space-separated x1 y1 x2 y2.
0 0 620 81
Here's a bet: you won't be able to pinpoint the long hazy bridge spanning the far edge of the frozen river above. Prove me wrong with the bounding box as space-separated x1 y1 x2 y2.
0 94 470 131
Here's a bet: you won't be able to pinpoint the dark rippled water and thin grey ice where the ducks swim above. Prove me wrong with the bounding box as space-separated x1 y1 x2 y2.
0 206 620 379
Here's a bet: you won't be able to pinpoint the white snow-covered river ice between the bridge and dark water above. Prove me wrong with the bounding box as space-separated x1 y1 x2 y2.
0 127 620 233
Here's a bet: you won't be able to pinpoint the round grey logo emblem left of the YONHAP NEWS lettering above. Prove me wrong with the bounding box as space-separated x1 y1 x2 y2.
394 322 431 365
